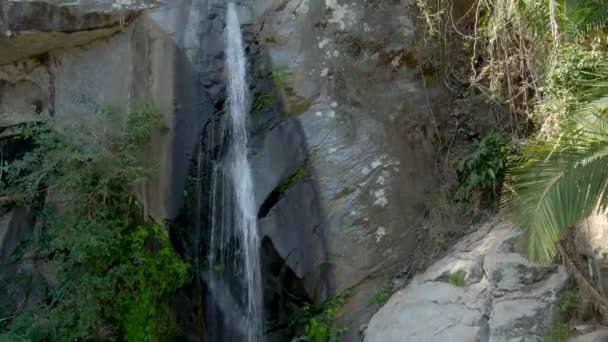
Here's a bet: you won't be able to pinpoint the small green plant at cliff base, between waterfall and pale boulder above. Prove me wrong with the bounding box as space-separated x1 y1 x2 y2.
291 294 348 342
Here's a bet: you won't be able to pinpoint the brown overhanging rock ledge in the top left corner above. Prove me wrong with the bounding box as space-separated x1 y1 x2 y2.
0 0 153 65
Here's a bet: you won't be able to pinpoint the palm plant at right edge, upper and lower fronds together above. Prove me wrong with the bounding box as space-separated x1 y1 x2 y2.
506 69 608 262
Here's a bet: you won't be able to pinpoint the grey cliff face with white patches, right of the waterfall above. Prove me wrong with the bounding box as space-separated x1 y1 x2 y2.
245 0 437 334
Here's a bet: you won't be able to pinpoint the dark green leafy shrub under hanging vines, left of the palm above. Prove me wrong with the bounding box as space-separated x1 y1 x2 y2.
456 133 510 200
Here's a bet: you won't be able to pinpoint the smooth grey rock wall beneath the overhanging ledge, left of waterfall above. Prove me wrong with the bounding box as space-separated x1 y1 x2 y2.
47 1 202 219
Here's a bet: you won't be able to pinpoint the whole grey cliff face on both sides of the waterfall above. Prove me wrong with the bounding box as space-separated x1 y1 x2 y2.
0 0 440 341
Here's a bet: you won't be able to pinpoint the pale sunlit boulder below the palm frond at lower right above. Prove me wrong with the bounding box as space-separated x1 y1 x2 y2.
365 222 568 342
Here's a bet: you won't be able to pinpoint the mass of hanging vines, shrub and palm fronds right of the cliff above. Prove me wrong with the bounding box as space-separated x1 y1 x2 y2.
418 0 608 262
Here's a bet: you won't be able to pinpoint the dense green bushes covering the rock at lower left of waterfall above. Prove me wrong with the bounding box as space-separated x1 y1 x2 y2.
0 106 189 342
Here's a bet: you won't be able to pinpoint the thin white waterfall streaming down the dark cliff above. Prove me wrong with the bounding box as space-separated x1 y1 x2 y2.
207 3 263 342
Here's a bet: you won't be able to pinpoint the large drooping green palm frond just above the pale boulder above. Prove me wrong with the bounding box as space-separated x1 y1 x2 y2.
510 137 608 262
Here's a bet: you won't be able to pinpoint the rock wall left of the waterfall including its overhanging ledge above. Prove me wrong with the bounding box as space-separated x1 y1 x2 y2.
0 1 201 219
